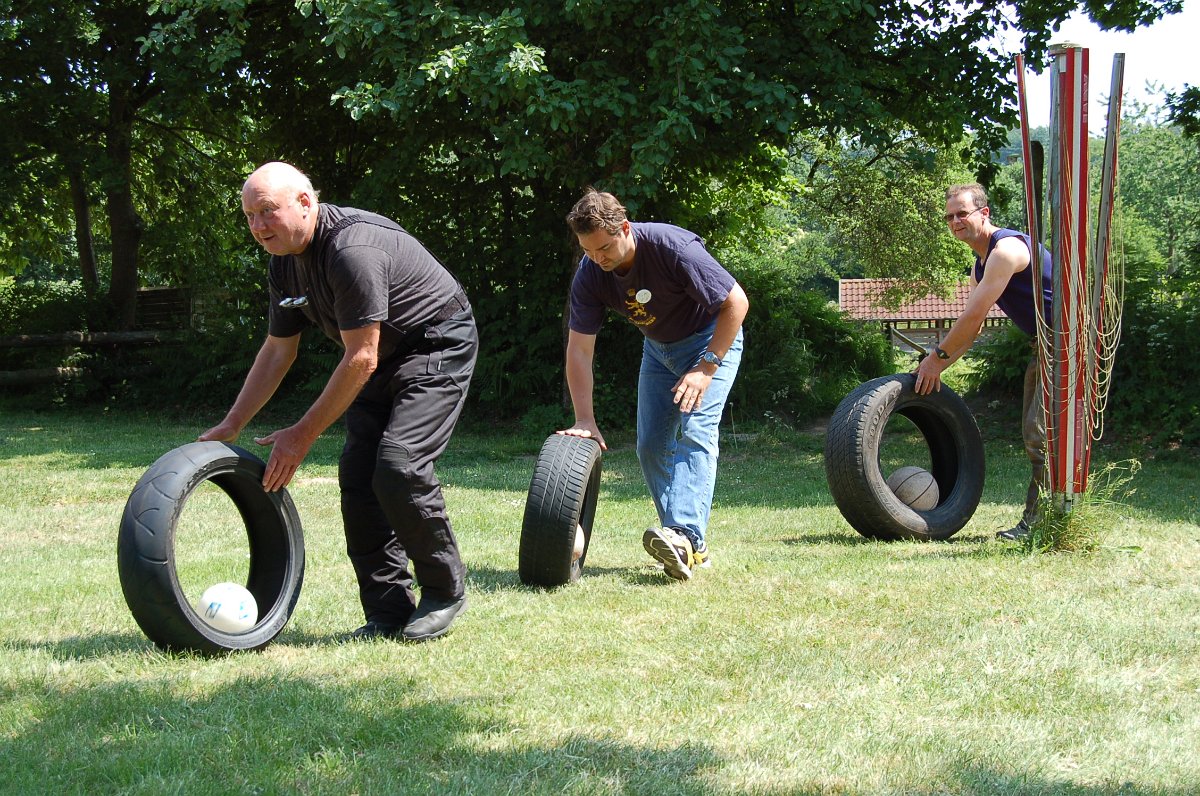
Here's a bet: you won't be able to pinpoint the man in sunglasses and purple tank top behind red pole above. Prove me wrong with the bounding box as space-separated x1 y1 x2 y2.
917 182 1051 541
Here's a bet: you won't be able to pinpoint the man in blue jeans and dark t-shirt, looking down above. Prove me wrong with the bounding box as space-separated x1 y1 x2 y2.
558 190 750 580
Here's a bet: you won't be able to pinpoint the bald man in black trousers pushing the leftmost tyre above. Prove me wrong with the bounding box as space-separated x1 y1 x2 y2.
199 163 479 641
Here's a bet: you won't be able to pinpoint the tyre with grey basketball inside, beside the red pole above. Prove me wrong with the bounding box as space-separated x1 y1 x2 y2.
826 373 984 540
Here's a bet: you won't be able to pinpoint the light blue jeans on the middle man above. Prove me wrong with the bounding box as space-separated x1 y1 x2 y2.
637 322 742 545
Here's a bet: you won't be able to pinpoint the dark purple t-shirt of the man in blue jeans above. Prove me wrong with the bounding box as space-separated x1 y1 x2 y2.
569 223 736 342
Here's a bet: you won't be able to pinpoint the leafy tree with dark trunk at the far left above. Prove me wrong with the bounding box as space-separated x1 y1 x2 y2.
0 0 255 328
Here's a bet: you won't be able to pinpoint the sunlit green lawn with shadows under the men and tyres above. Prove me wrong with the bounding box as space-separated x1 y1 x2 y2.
0 413 1200 795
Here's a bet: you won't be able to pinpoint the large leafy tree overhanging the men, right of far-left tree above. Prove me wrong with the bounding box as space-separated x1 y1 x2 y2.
138 0 1180 405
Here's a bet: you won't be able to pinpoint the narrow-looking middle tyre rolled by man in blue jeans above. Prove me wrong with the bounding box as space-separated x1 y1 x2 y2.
518 433 600 588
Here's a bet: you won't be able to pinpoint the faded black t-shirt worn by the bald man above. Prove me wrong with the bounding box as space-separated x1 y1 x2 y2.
268 203 461 359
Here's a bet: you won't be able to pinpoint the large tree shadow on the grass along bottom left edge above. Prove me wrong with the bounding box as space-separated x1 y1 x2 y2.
0 677 724 795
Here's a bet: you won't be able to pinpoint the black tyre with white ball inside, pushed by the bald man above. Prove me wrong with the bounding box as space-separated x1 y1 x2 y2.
116 442 304 656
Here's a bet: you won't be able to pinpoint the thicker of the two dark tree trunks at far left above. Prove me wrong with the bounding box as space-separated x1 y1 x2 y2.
104 86 145 329
